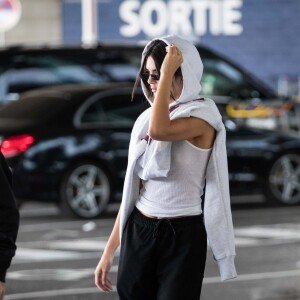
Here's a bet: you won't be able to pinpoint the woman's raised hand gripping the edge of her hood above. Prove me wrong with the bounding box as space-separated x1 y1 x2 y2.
160 44 183 76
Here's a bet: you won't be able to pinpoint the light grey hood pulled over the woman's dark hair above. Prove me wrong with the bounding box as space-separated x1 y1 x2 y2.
141 35 203 105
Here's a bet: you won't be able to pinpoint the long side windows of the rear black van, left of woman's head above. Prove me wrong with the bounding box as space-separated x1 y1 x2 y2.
0 52 138 102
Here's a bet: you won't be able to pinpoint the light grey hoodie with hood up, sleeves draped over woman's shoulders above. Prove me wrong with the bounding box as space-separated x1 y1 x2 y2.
120 35 236 280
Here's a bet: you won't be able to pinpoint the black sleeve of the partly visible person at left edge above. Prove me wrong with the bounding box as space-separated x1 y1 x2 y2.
0 152 19 282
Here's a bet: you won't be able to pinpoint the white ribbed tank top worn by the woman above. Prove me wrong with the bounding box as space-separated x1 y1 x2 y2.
136 140 211 218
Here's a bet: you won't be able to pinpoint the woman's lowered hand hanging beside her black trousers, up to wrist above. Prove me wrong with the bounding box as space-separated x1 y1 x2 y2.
95 254 113 292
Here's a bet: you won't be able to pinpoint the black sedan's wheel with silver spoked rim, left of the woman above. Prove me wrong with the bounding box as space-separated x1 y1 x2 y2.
61 162 111 219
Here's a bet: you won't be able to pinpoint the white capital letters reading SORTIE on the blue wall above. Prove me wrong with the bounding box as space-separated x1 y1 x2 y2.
119 0 243 38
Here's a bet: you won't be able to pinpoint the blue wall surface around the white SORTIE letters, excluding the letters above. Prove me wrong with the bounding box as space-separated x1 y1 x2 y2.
62 0 300 93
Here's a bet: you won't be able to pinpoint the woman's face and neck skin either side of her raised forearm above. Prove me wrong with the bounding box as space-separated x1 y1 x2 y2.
145 56 183 102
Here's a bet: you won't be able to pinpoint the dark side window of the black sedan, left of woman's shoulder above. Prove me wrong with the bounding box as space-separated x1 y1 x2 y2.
75 92 149 127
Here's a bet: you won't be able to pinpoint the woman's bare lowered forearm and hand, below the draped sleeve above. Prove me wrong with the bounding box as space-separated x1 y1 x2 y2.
95 212 120 292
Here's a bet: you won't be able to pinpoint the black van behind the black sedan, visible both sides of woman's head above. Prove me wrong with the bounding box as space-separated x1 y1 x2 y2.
0 43 276 104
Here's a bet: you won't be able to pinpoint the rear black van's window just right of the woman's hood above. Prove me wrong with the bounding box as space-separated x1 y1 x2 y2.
201 58 259 99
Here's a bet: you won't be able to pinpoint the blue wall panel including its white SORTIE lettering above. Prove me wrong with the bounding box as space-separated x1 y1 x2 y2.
63 0 300 87
